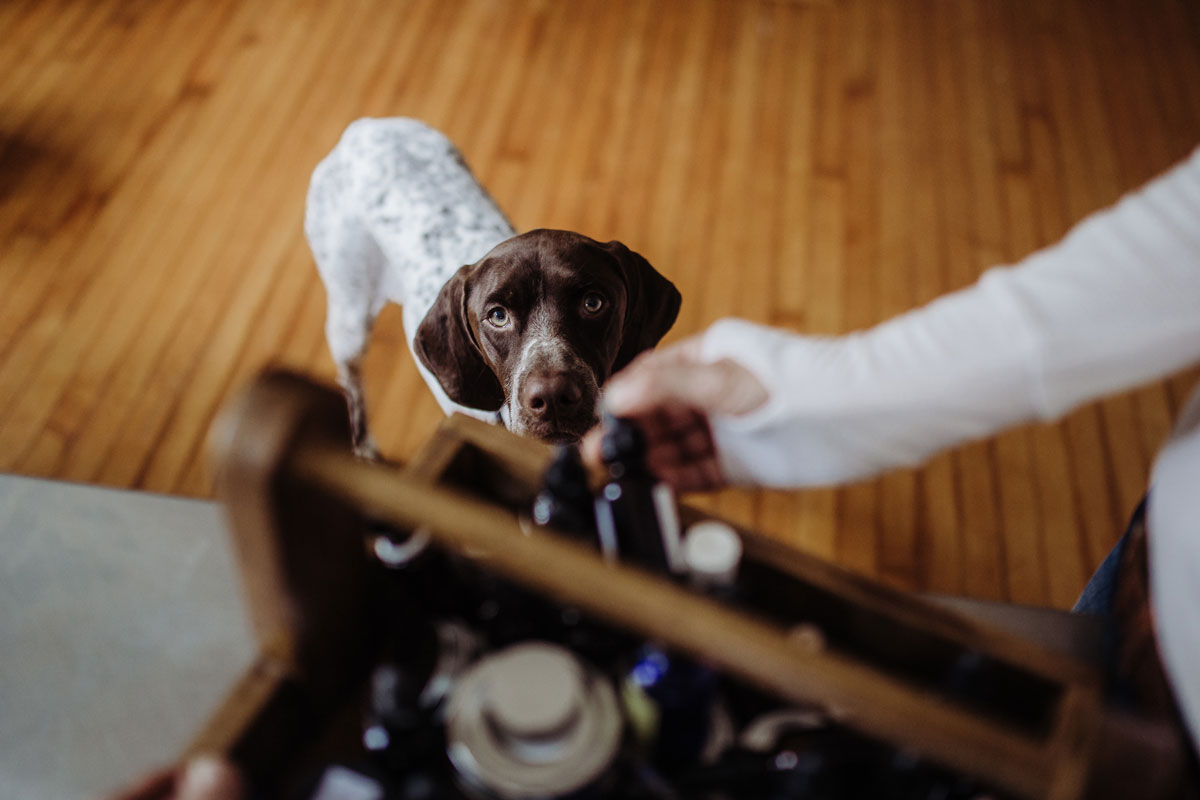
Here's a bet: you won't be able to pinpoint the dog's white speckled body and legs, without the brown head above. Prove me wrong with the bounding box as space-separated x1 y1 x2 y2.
305 118 516 452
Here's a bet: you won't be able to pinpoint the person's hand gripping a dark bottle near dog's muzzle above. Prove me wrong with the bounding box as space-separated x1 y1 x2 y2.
581 336 768 492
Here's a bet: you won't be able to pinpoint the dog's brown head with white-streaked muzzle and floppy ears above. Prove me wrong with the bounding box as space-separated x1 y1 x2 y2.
414 230 680 441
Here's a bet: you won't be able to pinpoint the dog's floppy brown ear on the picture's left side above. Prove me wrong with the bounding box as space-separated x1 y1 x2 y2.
413 265 504 411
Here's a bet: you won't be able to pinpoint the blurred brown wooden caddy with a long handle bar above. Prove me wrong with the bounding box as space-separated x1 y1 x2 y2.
192 373 1174 800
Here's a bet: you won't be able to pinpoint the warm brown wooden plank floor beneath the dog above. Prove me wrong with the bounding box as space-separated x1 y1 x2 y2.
0 0 1200 607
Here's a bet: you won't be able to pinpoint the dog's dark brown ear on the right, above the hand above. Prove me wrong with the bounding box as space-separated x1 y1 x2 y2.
604 241 683 372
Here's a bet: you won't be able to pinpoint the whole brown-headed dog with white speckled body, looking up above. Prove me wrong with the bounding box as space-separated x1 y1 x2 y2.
305 118 682 458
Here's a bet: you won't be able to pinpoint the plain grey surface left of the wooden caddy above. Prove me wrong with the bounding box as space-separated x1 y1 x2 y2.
0 475 253 800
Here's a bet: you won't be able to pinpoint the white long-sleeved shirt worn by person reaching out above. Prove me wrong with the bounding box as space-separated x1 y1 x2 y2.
702 150 1200 753
